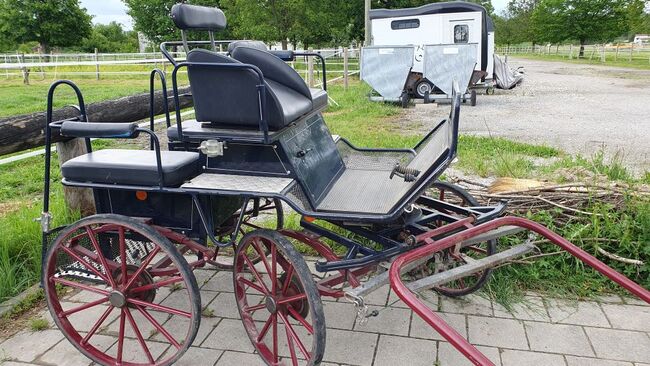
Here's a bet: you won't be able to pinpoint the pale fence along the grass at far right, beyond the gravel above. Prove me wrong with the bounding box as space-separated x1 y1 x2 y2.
496 43 650 64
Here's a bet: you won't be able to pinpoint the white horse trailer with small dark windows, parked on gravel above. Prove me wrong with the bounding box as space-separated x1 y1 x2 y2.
362 1 494 104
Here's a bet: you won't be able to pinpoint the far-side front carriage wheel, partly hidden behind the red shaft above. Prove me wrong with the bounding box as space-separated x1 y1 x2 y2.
420 181 497 297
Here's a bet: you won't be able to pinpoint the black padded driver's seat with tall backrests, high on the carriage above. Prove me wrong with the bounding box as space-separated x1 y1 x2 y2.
187 47 312 130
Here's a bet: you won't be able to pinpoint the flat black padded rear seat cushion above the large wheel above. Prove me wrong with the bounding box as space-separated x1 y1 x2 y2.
61 149 201 187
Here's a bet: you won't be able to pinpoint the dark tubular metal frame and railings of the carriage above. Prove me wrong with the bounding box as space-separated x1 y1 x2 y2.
42 71 496 272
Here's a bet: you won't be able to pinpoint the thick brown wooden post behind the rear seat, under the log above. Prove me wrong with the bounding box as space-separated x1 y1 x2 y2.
56 139 95 217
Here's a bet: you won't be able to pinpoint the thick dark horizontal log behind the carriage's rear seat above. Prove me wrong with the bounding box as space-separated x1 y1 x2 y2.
0 87 194 156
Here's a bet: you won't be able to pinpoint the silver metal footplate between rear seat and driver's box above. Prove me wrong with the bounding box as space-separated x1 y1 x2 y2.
182 173 293 194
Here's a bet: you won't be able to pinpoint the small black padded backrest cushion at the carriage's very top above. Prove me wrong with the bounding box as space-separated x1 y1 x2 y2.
171 3 228 31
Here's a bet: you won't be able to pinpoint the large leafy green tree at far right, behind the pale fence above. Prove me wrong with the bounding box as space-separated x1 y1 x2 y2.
531 0 630 57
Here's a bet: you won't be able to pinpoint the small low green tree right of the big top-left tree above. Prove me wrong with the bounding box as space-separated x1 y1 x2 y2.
82 22 138 52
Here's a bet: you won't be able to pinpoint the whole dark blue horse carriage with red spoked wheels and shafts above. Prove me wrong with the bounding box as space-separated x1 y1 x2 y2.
41 4 650 365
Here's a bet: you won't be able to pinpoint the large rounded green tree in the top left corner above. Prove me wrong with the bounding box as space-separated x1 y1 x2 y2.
0 0 92 53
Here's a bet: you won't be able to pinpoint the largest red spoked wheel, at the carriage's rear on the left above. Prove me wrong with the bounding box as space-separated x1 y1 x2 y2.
43 214 201 366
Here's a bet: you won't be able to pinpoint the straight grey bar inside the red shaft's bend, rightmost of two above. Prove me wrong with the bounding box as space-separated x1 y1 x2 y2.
406 243 537 292
